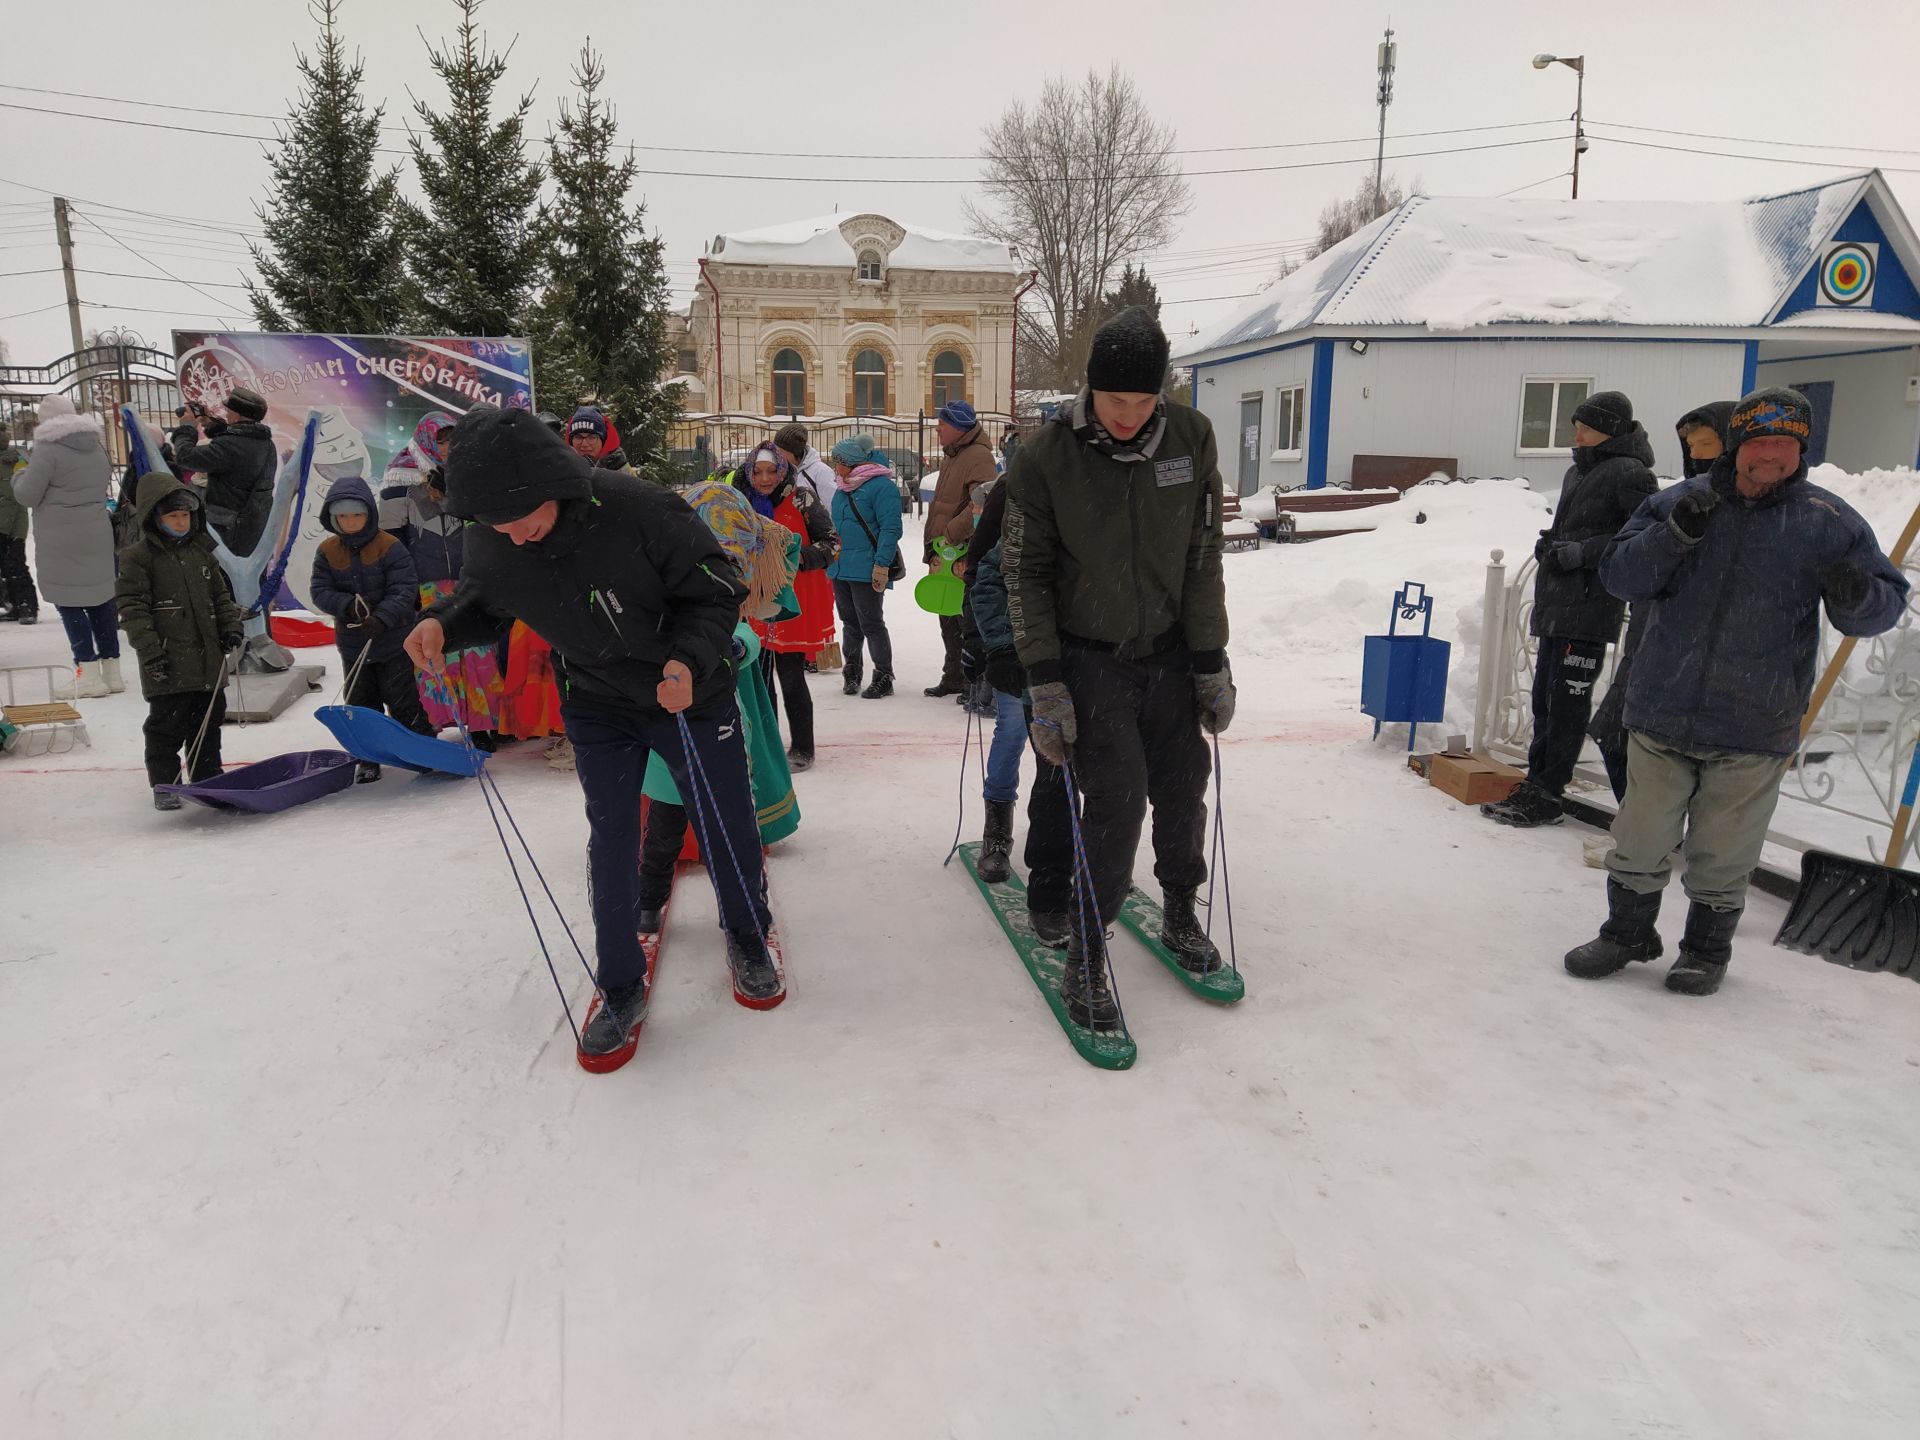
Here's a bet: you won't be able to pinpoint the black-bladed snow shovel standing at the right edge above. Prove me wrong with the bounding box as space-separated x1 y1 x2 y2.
1774 745 1920 979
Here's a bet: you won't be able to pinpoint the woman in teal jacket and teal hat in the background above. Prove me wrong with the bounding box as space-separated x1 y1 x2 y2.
828 436 902 701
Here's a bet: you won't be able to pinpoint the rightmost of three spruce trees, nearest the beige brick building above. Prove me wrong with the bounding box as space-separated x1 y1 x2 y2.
530 40 680 461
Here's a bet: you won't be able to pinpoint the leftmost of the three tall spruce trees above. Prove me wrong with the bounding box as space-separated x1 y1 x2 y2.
246 0 413 334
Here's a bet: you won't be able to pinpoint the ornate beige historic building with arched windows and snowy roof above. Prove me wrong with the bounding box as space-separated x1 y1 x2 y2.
689 215 1025 417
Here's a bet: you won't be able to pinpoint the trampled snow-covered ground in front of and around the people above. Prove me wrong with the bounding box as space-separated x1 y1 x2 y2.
0 486 1920 1440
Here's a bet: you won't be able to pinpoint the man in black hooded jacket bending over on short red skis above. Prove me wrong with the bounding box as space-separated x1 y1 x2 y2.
407 407 780 1069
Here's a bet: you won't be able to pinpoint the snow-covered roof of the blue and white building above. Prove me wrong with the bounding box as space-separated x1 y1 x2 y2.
1181 171 1920 361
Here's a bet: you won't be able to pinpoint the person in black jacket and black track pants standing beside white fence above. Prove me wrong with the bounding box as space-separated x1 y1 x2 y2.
1480 390 1659 826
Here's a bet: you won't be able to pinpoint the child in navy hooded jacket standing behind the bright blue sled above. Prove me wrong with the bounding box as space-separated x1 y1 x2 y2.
311 476 434 783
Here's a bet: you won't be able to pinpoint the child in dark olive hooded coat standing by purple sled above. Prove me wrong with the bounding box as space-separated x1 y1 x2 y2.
115 472 242 810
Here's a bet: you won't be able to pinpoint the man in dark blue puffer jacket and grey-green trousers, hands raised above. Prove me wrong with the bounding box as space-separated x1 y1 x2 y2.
1565 388 1908 995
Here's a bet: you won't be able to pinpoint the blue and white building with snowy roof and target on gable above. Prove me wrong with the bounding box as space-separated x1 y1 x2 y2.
1175 171 1920 495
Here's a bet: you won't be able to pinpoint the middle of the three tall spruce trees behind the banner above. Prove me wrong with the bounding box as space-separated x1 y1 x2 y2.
407 0 541 337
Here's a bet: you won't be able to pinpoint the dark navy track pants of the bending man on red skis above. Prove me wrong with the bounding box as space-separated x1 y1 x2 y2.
561 695 772 989
